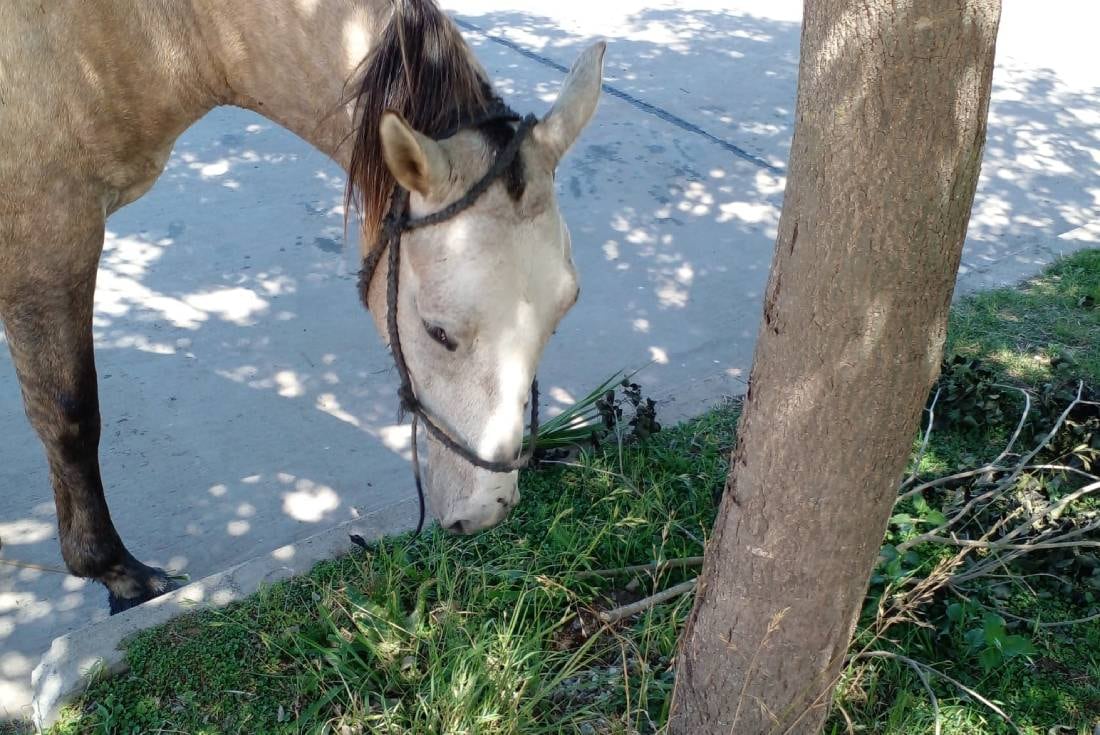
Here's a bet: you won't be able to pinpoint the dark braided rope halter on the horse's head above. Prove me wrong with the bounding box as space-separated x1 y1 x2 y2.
359 102 539 535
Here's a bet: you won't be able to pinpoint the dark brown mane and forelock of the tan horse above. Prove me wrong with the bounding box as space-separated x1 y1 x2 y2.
344 0 523 246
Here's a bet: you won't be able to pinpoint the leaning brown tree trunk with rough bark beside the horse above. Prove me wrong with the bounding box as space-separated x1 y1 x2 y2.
670 0 1000 735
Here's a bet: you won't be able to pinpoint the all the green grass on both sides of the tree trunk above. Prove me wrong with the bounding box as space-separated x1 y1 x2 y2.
42 251 1100 735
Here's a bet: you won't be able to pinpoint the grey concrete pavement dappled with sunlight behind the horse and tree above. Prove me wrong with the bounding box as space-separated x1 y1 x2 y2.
0 0 1100 714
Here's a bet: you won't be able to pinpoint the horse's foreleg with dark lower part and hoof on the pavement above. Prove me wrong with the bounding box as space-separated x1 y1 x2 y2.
0 224 175 614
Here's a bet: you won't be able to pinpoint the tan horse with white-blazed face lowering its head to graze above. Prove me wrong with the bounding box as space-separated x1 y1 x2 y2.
0 0 604 613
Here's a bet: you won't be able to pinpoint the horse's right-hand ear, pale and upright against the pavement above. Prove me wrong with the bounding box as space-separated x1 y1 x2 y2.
531 41 607 166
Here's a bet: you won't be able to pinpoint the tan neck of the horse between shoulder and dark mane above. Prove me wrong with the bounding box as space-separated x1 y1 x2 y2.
194 0 389 169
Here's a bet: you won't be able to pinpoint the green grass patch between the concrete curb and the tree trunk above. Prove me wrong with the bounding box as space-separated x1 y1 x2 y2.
54 406 736 734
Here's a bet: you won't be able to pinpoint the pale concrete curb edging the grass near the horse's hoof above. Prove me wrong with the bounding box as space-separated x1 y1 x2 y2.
31 500 417 728
